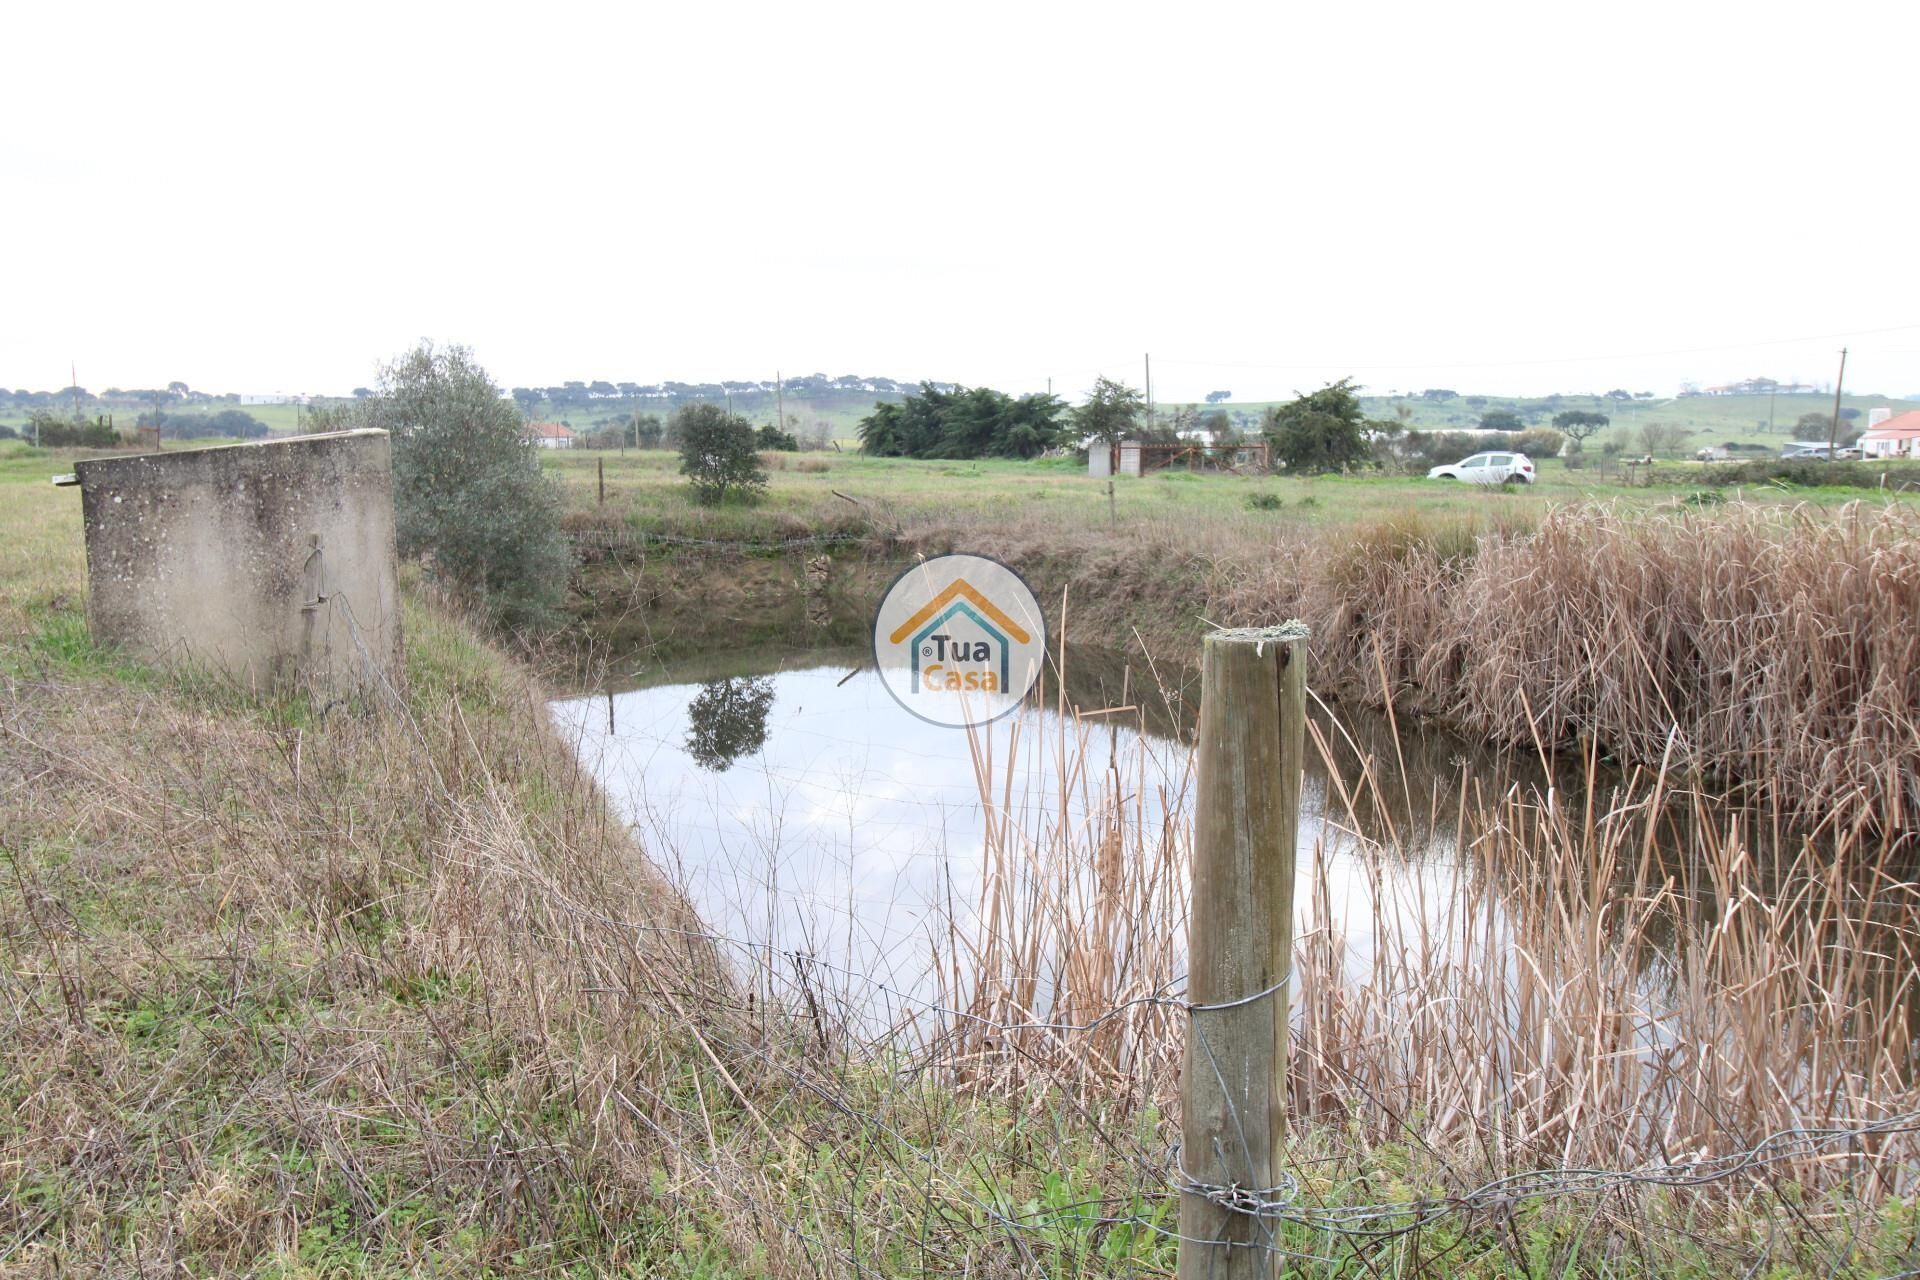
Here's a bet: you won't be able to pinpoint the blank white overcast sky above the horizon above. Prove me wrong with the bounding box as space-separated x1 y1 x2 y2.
0 0 1920 399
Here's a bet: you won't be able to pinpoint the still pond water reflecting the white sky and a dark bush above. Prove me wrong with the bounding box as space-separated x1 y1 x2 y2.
553 651 1484 1002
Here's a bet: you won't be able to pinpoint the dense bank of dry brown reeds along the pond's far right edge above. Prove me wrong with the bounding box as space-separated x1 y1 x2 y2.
1212 503 1920 825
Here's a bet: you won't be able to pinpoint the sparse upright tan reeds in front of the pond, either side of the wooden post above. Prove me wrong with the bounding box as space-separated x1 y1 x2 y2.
941 667 1920 1234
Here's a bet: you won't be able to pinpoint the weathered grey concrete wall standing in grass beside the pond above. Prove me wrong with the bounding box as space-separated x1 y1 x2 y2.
73 430 401 691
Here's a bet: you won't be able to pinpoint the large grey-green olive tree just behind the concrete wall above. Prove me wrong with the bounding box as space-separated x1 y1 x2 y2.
371 342 572 629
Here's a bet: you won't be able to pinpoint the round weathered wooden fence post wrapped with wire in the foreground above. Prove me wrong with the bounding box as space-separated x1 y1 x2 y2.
1179 624 1306 1280
